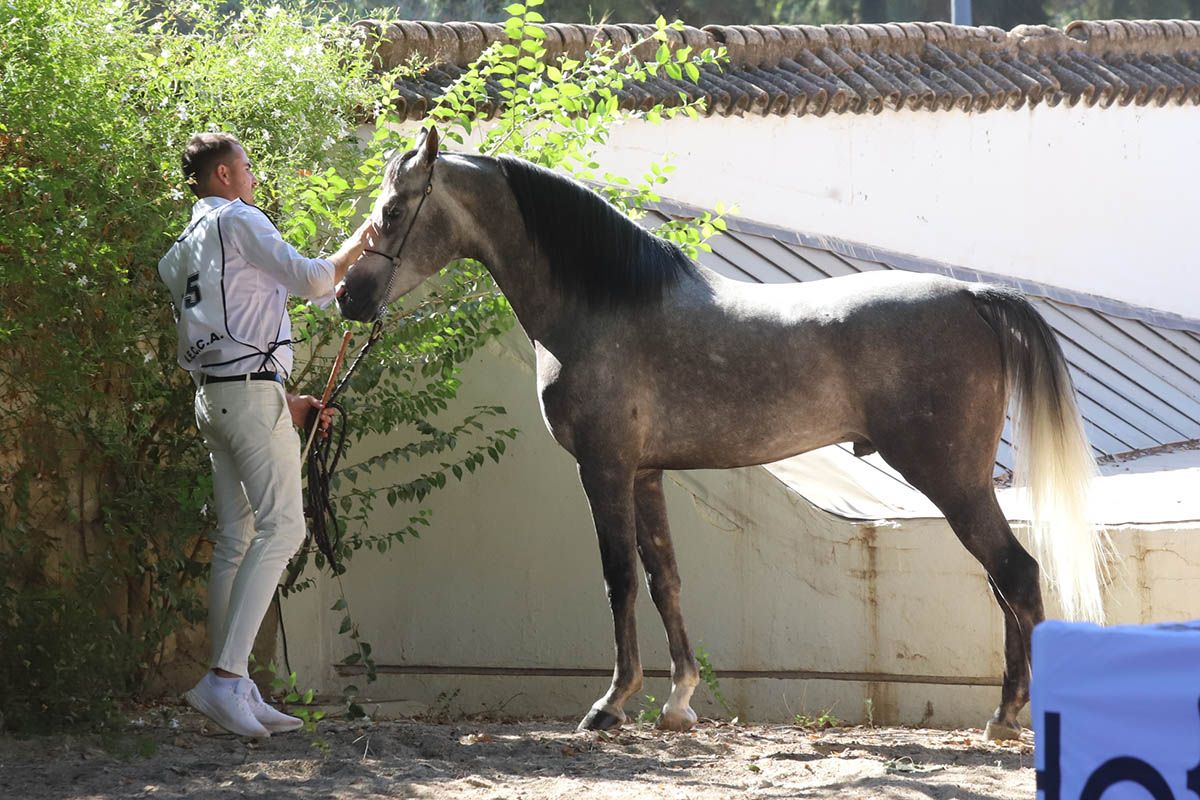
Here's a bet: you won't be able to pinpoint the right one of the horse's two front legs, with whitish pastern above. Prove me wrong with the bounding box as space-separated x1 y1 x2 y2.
634 470 700 730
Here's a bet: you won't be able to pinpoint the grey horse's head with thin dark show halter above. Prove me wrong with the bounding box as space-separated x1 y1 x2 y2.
337 128 449 321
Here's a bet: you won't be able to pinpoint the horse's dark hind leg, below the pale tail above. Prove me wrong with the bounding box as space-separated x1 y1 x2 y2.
875 438 1044 739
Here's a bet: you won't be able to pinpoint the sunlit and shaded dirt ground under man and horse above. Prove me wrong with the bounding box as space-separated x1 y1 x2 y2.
0 706 1034 800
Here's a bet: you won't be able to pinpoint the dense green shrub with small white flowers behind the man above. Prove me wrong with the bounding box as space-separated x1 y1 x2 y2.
0 0 436 729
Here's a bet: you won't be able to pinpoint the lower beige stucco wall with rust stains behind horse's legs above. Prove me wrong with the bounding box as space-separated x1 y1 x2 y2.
284 331 1200 726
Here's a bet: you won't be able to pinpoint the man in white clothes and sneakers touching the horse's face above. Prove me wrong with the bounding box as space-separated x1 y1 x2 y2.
158 133 367 736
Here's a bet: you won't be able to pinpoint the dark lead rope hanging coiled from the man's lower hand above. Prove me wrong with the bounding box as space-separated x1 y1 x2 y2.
305 309 383 575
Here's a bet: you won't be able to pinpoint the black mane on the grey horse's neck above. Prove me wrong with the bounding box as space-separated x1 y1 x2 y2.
499 156 694 307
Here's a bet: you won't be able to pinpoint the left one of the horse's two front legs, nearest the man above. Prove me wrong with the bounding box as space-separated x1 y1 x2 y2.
578 459 642 730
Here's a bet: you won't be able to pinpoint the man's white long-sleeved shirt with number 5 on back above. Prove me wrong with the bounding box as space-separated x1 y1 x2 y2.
158 197 335 378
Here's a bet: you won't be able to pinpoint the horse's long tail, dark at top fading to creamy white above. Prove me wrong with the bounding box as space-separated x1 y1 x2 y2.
976 287 1108 622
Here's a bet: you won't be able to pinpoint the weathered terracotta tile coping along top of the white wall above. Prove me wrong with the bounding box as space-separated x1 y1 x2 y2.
354 19 1200 119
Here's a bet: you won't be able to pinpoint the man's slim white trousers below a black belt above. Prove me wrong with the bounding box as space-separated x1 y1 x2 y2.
196 380 305 675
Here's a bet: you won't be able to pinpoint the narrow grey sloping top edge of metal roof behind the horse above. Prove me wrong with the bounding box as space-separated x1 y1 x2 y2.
650 199 1200 335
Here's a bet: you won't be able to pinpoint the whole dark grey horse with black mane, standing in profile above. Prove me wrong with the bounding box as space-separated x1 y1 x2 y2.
338 131 1102 738
